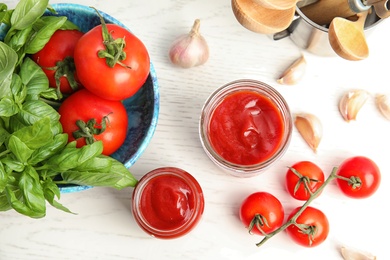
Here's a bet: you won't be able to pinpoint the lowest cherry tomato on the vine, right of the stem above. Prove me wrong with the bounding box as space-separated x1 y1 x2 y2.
286 207 329 247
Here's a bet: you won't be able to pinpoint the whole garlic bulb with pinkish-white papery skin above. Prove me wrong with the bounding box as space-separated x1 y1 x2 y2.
169 19 209 68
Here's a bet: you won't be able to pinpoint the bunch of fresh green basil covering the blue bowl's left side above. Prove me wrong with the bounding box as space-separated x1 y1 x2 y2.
0 0 137 218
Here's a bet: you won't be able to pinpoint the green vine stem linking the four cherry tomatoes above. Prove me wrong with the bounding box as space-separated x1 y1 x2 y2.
256 167 340 247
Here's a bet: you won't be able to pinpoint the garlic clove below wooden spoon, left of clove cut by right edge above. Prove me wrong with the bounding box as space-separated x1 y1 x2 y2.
339 89 370 122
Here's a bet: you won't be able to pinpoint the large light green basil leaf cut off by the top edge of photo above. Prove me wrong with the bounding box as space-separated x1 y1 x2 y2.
11 0 49 30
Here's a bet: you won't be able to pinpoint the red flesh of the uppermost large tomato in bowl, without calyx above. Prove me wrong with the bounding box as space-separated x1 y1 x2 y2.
74 24 150 100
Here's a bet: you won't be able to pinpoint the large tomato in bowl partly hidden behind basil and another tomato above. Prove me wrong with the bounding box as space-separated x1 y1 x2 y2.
32 30 84 94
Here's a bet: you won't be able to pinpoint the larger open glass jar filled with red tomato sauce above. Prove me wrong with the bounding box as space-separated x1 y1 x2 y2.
199 79 293 177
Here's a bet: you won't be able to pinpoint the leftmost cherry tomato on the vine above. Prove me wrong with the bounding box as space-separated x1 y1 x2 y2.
239 192 284 235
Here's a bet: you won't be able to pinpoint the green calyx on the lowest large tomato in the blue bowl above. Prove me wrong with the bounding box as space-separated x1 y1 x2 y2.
72 115 109 144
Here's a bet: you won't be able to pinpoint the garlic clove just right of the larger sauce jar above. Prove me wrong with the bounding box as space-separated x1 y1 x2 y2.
294 113 322 153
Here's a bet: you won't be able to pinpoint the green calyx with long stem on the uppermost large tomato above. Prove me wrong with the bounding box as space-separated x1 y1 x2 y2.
92 7 131 69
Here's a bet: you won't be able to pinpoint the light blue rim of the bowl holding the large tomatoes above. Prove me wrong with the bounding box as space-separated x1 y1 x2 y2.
51 3 160 193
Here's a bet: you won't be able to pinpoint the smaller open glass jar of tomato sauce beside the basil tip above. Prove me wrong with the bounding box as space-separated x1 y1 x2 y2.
132 167 204 239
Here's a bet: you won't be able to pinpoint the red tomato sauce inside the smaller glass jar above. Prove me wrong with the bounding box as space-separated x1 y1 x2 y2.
141 175 195 230
